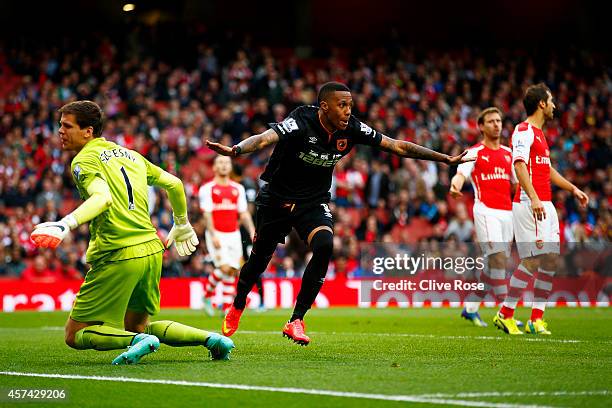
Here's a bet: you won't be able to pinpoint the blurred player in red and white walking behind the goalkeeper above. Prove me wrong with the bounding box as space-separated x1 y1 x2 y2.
199 156 255 316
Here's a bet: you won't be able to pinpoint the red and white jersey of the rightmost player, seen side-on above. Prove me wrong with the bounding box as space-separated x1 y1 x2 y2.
512 122 552 203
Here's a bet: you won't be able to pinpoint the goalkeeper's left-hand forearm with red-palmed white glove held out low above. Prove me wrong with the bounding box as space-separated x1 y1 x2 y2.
30 177 113 249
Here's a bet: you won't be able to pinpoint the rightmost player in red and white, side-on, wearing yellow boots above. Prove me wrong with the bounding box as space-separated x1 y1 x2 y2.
493 83 589 335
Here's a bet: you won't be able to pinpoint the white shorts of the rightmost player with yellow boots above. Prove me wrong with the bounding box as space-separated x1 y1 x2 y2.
512 201 560 259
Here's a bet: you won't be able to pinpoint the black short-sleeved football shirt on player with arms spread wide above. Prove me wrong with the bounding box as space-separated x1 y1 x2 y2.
261 106 382 204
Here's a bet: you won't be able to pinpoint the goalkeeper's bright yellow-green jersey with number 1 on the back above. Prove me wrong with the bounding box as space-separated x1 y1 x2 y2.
71 137 163 263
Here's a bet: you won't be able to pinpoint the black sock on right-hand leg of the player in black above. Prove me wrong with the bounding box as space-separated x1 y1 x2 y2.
290 230 334 322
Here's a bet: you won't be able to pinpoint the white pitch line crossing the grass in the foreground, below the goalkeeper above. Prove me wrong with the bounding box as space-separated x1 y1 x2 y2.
0 371 552 408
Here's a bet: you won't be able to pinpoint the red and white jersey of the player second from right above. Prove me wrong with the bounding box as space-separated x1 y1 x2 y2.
457 143 516 211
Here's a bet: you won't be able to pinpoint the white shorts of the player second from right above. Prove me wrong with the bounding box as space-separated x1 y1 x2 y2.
474 202 514 257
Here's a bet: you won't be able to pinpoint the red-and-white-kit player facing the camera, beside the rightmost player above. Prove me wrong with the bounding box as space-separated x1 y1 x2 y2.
450 107 515 327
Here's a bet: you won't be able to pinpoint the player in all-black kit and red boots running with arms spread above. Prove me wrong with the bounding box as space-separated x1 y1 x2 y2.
207 82 469 345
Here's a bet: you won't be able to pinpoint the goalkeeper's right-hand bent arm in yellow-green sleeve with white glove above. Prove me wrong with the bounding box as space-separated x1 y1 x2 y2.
147 165 200 256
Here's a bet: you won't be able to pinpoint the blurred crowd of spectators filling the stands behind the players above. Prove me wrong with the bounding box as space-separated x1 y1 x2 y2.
0 33 612 281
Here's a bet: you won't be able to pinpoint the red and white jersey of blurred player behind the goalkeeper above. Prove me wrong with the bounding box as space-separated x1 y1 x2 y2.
199 180 247 232
